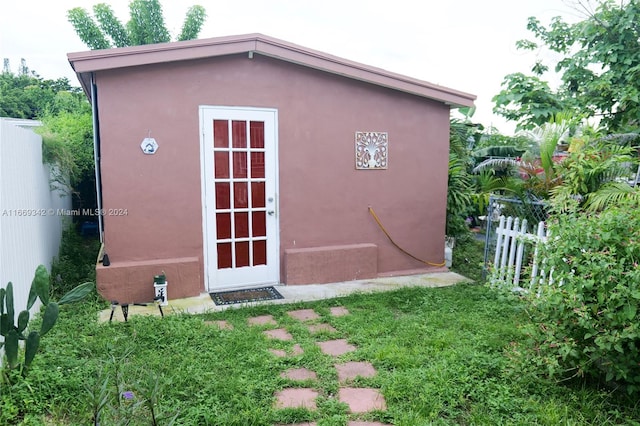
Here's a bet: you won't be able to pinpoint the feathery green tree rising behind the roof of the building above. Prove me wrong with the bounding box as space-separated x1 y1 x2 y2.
67 0 207 50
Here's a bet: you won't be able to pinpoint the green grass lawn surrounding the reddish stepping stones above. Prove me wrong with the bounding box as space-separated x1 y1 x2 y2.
0 284 640 426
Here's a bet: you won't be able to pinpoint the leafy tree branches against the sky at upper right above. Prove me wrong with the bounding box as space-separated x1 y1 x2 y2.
493 0 640 131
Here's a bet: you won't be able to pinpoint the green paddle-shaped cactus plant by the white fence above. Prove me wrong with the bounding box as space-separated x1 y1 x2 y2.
0 265 94 374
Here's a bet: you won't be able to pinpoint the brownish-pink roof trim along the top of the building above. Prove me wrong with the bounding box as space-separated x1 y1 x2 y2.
67 34 476 107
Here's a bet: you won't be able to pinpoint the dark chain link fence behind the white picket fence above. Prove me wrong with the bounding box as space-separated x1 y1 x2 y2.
482 195 549 279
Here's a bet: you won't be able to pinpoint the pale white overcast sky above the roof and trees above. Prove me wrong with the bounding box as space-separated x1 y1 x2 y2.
0 0 582 134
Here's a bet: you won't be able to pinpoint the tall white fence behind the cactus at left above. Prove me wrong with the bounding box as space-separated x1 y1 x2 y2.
0 118 71 312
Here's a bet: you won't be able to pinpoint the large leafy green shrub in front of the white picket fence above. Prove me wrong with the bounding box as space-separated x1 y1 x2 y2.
530 201 640 392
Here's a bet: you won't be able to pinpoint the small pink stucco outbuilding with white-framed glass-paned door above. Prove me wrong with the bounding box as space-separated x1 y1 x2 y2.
68 34 475 303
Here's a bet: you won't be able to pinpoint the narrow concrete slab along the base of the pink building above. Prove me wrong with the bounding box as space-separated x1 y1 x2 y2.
99 271 469 321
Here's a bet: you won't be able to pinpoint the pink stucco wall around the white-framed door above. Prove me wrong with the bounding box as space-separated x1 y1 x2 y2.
96 55 449 301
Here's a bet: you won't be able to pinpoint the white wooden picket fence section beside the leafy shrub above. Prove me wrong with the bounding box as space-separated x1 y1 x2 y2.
489 216 552 290
